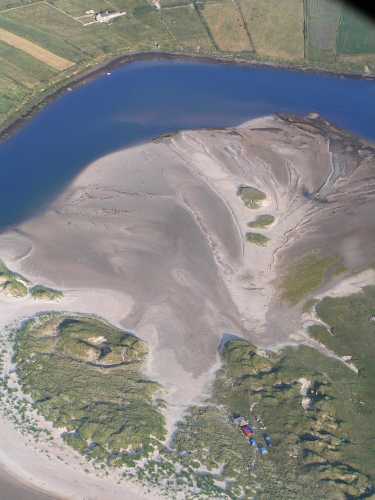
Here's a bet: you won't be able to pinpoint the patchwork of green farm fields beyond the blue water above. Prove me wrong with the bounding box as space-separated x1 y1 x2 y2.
0 0 375 136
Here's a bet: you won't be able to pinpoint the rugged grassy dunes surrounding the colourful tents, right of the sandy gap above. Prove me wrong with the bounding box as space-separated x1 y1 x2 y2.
171 326 375 499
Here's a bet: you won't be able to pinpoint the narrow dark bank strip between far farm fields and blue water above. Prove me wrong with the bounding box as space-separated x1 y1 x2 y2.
0 52 375 146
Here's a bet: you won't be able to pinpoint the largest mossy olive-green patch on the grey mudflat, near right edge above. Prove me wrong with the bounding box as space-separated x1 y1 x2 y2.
281 253 344 305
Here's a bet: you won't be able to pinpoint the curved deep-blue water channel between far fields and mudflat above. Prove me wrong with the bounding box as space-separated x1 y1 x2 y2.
0 62 375 229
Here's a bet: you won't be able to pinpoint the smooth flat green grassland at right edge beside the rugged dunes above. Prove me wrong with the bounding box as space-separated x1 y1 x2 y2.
310 286 375 480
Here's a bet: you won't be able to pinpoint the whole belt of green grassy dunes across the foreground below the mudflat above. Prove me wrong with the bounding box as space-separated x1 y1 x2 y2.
11 287 375 500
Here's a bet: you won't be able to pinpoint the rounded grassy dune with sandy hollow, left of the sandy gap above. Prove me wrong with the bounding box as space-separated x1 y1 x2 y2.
15 314 165 464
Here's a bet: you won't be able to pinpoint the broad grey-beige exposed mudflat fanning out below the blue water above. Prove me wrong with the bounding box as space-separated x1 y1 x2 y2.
0 113 375 422
